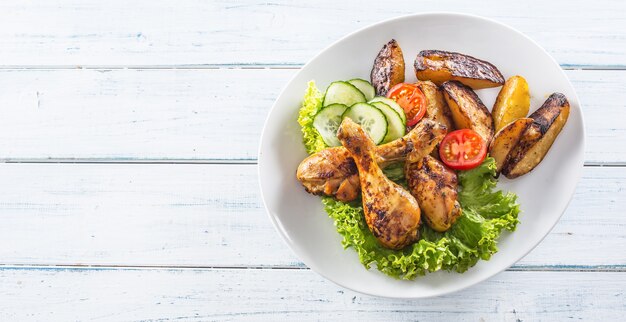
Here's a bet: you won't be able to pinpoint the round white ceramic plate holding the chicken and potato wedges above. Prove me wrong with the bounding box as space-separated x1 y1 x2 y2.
259 13 585 298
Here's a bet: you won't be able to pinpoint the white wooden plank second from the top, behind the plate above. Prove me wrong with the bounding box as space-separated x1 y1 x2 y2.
0 69 626 163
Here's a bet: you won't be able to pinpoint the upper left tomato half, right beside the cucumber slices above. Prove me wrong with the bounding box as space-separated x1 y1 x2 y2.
387 83 426 126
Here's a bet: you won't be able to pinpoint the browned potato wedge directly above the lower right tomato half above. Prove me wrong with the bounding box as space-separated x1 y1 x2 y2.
441 81 493 146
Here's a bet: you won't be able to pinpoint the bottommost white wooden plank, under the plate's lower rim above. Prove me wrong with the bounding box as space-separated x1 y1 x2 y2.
0 268 626 321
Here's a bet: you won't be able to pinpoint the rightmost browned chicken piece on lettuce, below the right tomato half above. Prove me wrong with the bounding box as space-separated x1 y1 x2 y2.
404 156 461 232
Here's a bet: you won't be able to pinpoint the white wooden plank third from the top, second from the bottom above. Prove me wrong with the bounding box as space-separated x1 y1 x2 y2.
0 164 626 270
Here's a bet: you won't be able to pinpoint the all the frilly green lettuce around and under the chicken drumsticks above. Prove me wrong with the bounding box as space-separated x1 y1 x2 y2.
298 82 520 280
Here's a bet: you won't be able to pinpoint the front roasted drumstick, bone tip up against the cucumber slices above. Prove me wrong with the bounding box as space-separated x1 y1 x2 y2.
337 119 420 249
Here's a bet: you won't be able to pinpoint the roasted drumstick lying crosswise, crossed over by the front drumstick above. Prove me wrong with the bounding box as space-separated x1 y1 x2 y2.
296 119 446 201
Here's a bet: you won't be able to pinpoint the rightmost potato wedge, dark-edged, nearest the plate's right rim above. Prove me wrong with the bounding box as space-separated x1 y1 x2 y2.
502 93 570 179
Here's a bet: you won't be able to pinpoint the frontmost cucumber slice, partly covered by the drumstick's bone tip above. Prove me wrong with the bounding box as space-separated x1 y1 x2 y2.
343 103 387 144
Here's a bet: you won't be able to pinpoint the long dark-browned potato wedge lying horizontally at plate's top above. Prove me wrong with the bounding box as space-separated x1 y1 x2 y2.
413 50 504 89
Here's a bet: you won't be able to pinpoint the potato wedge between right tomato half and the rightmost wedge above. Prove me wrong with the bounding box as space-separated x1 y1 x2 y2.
489 117 533 175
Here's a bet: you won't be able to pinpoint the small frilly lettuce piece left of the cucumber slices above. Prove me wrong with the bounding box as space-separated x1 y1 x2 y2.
298 81 327 154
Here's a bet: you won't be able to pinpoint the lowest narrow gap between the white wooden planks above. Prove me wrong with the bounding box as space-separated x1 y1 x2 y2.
0 263 626 273
